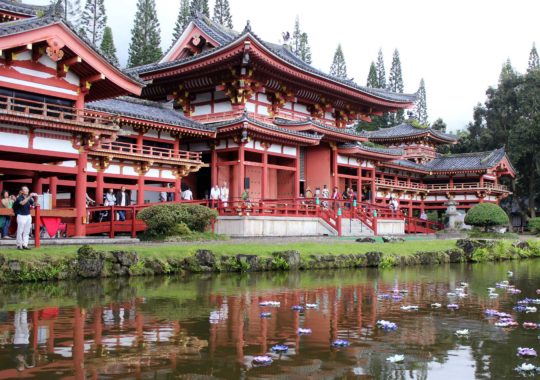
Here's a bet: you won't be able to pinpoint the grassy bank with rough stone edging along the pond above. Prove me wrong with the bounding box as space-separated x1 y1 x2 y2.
0 239 540 283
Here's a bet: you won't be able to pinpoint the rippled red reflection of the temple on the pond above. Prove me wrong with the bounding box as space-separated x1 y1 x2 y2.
0 274 510 379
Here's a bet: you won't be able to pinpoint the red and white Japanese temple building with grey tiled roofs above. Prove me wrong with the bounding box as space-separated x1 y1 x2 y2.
0 0 514 236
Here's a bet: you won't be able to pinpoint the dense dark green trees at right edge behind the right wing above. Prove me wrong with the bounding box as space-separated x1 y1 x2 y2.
452 47 540 217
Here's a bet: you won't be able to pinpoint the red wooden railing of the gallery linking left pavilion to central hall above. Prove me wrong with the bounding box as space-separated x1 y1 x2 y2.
93 141 202 161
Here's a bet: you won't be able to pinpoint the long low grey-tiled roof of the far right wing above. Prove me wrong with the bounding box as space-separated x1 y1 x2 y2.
389 148 513 172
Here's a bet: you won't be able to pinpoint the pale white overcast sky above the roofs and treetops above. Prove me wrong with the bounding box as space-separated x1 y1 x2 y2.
33 0 540 131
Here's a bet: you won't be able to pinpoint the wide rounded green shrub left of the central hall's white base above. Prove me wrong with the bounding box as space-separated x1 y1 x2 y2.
137 204 217 236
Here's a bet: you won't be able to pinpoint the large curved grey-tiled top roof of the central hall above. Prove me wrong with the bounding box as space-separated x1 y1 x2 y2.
129 14 416 103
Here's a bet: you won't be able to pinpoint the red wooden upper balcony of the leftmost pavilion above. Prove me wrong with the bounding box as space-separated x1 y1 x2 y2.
0 95 118 133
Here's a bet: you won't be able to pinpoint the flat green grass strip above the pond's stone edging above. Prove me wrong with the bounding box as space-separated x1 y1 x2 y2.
0 239 456 260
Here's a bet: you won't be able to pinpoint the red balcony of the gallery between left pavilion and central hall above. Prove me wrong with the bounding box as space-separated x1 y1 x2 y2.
90 141 203 166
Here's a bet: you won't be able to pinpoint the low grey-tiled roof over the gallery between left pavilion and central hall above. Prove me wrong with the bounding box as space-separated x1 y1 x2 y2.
86 96 212 131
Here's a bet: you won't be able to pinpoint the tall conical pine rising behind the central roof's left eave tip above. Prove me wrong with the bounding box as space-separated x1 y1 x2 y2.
128 0 162 67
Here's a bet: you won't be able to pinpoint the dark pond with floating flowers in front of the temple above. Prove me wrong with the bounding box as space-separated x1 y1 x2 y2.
0 260 540 380
